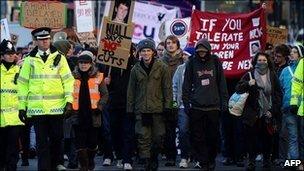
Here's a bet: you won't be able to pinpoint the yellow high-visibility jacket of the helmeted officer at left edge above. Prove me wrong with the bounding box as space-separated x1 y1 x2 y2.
0 64 24 127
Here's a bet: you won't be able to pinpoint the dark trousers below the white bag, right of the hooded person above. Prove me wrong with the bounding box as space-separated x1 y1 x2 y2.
221 111 245 160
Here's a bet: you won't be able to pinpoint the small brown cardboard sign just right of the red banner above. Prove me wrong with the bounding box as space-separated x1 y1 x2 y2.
267 26 288 46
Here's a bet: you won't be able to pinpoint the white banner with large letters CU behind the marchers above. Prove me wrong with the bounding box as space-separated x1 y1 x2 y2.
132 2 179 44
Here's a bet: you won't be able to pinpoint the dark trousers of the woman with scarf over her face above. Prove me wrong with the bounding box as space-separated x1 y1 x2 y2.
244 118 272 161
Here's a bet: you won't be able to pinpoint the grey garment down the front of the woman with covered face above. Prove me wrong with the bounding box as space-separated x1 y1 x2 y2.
254 69 272 118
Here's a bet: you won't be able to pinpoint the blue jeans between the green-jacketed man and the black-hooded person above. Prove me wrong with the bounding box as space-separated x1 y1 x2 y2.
178 108 190 159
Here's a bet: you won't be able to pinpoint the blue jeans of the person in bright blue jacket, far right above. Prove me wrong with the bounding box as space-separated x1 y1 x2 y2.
282 111 299 159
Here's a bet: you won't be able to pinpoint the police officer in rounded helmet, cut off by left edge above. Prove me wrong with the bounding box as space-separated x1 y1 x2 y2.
0 39 24 171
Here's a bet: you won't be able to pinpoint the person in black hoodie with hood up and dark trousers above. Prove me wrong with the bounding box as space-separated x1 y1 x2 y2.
182 39 228 170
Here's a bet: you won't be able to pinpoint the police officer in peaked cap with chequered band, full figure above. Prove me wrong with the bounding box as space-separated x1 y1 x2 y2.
18 27 74 170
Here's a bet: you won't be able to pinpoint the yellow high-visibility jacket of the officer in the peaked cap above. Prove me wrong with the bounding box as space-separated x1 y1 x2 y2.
18 46 74 117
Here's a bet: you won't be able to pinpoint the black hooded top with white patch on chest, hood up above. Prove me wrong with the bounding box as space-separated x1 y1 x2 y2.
182 40 228 111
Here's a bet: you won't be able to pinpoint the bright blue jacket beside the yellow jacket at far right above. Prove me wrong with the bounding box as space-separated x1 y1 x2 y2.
279 61 299 111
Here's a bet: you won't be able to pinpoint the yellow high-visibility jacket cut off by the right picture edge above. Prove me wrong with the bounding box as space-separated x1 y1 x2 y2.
290 59 304 116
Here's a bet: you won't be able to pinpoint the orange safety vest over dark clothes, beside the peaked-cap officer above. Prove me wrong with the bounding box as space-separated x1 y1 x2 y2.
73 73 103 110
